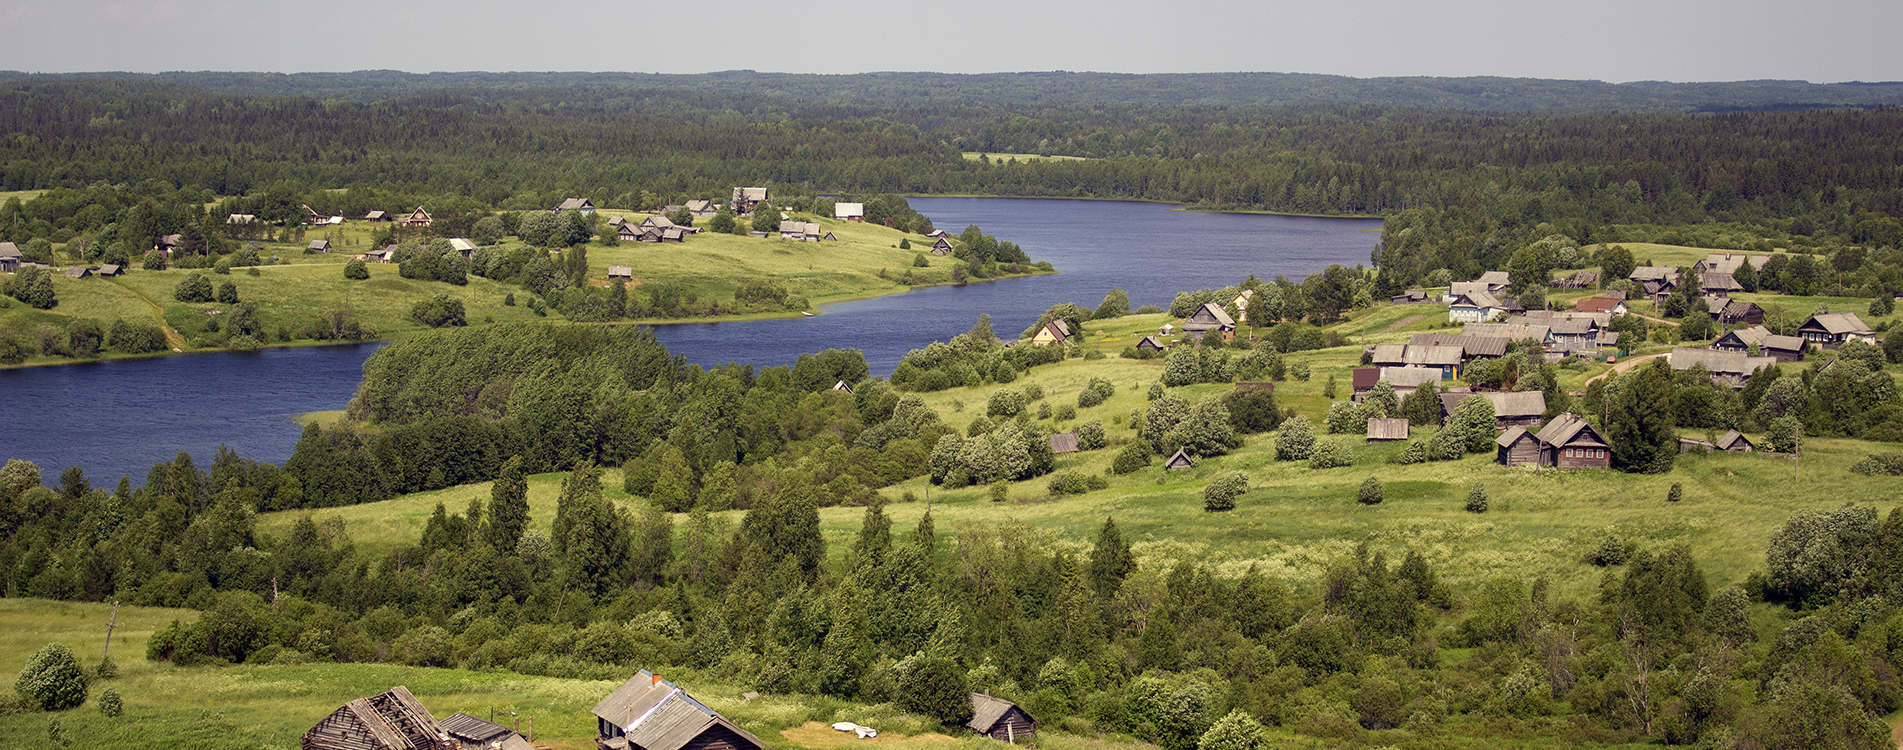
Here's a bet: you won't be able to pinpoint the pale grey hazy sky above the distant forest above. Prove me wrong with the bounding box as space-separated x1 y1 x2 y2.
0 0 1903 82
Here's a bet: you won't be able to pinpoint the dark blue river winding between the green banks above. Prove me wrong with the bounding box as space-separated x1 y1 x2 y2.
0 198 1382 485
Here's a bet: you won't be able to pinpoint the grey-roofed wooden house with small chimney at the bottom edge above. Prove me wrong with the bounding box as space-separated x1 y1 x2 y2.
592 670 765 750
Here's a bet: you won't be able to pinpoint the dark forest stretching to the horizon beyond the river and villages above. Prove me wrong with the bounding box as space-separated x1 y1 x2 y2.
0 72 1903 291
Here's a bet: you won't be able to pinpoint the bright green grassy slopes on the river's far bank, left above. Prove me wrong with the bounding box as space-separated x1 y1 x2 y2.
0 211 1042 364
